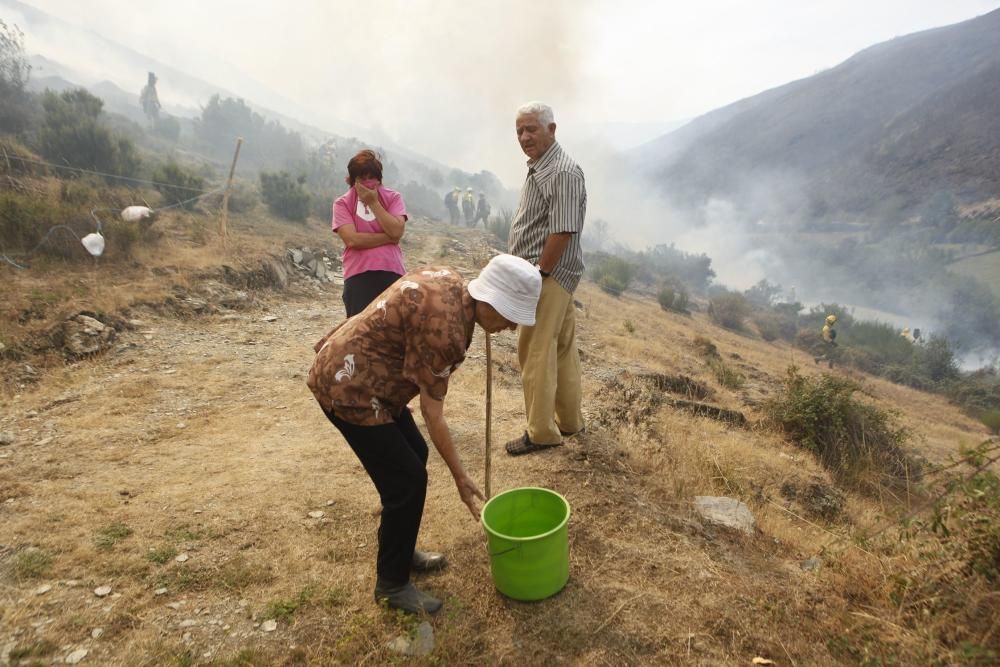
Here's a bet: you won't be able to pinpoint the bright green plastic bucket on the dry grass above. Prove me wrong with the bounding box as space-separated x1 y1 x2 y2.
482 487 569 600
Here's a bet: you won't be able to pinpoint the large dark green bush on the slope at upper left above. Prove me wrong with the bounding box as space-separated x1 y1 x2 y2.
38 88 139 176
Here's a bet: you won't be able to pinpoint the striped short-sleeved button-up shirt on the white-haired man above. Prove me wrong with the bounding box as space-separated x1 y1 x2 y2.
507 142 587 293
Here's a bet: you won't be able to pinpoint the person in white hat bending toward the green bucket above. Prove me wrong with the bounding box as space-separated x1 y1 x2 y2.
307 255 542 614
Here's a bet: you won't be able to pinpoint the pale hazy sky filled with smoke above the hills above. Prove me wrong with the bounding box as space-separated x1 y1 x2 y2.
15 0 998 185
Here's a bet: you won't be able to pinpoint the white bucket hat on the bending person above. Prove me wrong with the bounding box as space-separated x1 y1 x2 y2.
469 255 542 327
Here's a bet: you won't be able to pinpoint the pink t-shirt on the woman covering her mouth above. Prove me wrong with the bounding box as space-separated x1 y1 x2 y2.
333 185 406 278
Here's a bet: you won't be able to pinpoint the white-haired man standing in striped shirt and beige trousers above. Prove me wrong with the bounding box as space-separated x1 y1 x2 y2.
506 102 587 456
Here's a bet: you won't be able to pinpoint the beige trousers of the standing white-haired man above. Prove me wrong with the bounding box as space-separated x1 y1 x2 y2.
517 278 583 445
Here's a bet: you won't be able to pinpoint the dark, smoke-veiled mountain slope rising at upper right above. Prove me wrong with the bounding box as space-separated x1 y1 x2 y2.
639 10 1000 223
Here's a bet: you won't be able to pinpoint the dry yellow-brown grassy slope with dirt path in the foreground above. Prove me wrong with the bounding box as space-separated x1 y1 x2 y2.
0 192 998 665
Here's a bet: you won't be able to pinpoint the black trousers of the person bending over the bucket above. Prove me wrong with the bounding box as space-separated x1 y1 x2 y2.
324 408 427 585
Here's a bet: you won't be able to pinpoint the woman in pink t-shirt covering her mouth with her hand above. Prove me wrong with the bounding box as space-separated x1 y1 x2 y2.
333 150 407 317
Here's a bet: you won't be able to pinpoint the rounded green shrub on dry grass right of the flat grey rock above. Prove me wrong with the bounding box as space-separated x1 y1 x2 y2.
765 366 920 491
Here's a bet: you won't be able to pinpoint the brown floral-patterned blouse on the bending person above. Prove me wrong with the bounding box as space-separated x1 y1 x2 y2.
307 267 475 426
